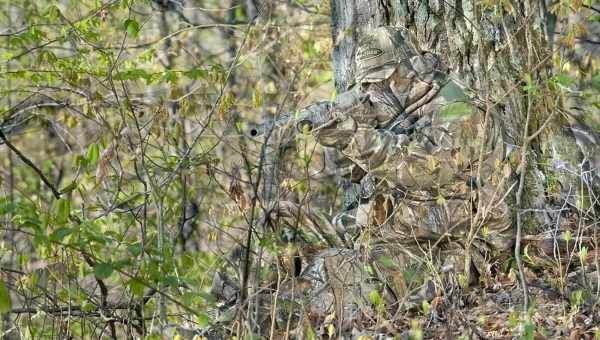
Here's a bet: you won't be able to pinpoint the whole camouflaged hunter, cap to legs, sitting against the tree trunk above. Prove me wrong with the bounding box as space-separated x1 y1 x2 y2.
210 27 513 338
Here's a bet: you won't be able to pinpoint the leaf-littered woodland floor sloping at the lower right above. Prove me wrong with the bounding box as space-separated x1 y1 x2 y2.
371 273 600 339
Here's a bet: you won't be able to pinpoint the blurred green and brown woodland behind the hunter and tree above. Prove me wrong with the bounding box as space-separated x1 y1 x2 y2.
0 0 600 339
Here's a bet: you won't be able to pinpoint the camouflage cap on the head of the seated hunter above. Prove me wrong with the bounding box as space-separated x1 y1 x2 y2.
355 26 419 83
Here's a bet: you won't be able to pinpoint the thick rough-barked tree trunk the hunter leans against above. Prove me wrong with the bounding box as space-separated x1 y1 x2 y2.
331 0 596 233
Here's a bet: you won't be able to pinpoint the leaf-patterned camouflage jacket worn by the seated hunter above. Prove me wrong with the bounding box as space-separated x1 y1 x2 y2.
314 77 512 254
